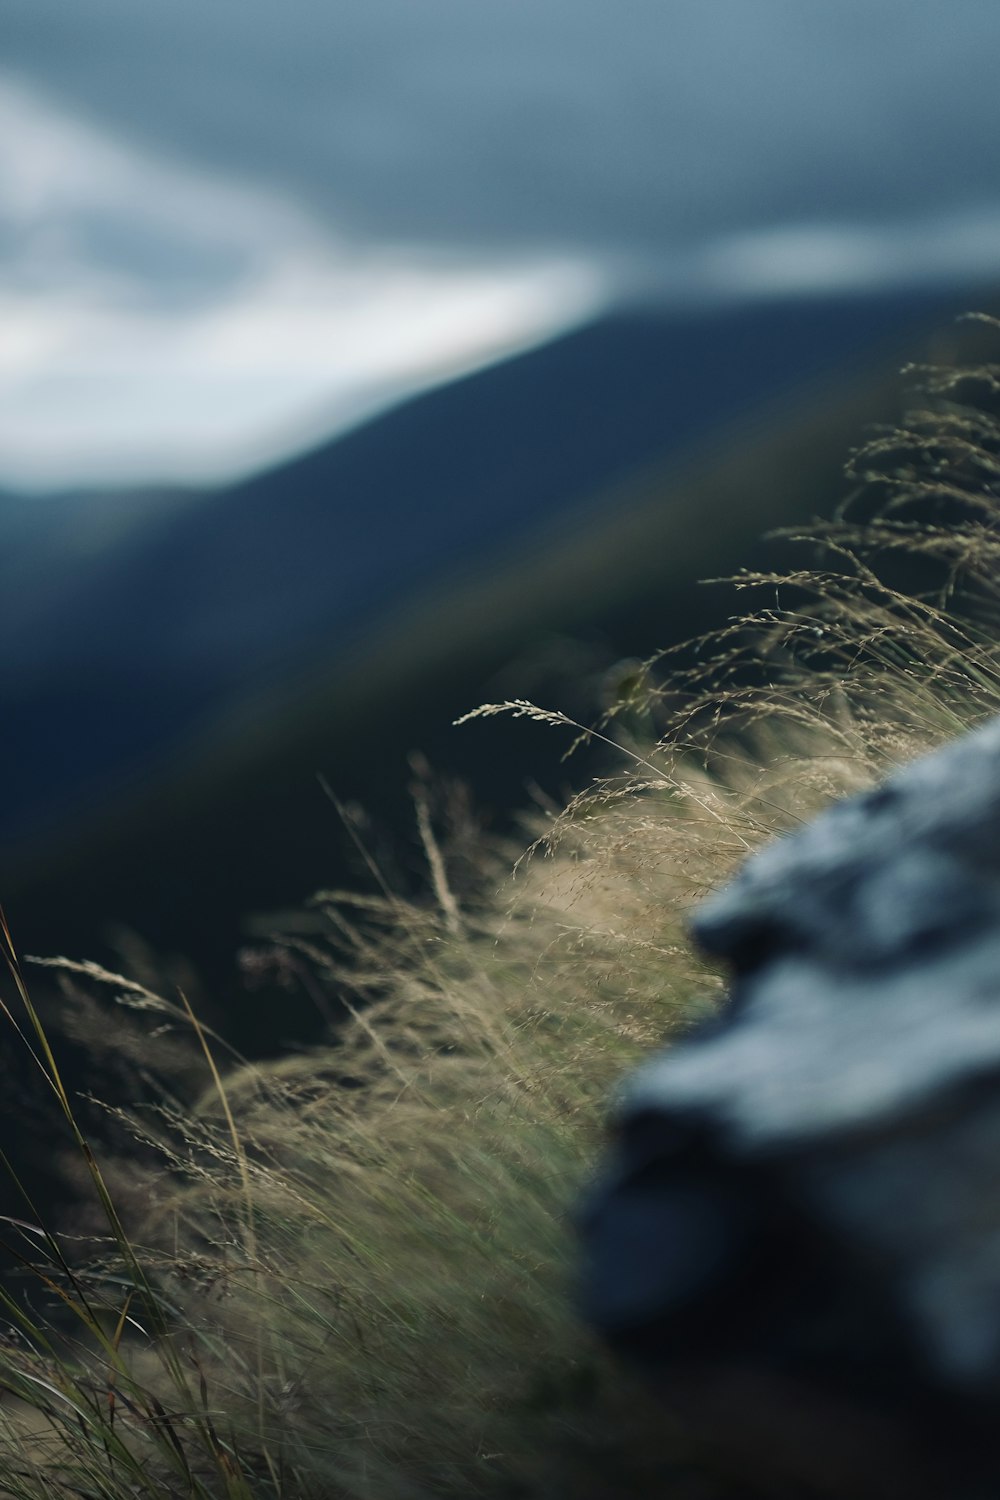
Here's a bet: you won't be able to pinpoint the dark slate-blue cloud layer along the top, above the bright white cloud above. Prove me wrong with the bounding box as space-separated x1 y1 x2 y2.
4 0 1000 258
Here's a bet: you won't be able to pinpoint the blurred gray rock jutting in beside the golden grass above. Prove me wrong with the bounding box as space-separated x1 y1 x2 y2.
582 720 1000 1496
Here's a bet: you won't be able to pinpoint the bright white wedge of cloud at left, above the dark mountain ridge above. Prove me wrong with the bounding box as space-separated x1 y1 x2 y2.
0 81 607 488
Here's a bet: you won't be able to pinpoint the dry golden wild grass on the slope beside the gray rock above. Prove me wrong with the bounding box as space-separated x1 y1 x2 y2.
0 322 1000 1500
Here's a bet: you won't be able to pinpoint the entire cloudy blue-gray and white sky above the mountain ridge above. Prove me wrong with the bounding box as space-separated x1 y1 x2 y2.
0 0 1000 489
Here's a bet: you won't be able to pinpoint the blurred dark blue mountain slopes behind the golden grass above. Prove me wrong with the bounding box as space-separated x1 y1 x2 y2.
0 296 983 1044
